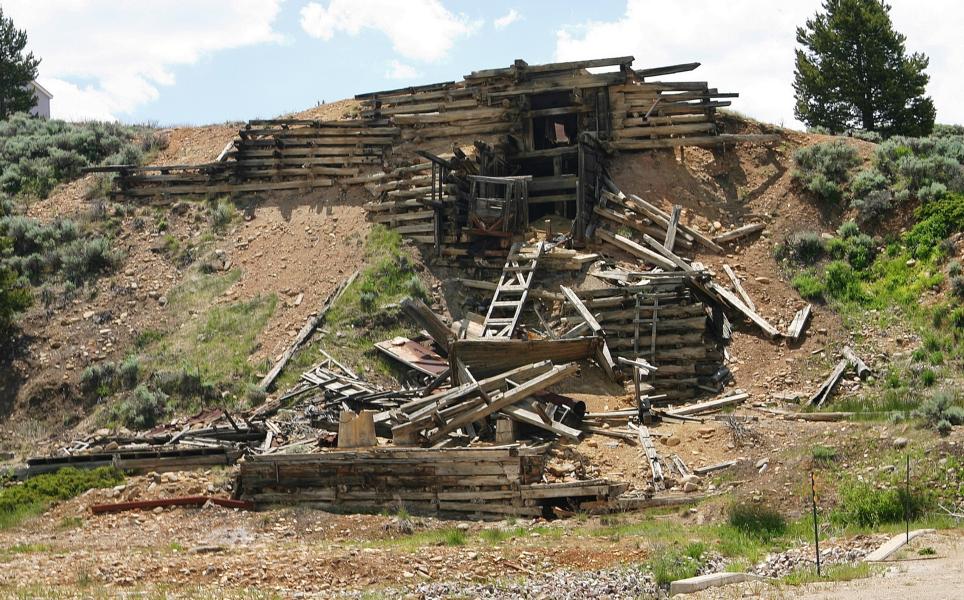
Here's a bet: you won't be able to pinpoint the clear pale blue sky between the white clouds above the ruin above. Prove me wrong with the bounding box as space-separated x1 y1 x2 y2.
126 0 625 124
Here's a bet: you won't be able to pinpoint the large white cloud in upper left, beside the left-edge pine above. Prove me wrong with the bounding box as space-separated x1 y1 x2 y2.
4 0 281 120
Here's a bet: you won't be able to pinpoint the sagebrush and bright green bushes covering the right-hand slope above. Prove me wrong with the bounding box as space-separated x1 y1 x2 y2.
777 127 964 431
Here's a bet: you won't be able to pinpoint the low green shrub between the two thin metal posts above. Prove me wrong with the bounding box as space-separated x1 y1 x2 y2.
830 481 927 528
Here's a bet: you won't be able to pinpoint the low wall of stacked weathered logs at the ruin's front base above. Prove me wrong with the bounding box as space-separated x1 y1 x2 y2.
240 445 625 518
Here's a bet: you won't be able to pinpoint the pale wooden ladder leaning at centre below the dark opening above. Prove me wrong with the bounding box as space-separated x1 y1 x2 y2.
482 242 544 338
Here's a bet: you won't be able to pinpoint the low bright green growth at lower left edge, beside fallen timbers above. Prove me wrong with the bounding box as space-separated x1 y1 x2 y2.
0 467 124 529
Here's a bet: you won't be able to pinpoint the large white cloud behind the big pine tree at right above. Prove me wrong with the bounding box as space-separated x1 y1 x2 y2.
555 0 964 127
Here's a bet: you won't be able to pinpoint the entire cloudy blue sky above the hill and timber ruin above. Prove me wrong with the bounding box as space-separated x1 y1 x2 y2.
3 0 964 126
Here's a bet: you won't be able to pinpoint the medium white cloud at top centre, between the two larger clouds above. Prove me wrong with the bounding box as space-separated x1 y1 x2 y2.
301 0 479 62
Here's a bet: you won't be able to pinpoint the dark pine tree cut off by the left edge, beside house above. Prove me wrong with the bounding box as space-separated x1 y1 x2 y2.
0 7 40 119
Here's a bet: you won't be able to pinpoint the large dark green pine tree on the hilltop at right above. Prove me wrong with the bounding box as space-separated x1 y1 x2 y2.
793 0 936 136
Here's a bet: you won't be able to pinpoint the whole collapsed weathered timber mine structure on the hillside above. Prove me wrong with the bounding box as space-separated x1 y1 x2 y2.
49 57 812 515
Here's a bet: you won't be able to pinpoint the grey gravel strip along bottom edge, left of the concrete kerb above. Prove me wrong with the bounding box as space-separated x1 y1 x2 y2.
342 568 659 600
